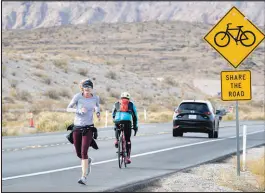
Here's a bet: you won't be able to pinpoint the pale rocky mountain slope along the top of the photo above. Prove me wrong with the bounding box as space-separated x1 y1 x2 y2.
2 1 265 29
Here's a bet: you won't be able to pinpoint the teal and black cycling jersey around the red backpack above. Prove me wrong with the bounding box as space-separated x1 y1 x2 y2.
112 101 138 127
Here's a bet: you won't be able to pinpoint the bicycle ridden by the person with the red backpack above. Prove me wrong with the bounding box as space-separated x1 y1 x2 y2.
117 123 136 168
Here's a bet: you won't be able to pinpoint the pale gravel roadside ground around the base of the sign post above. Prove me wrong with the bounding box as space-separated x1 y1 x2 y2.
136 146 265 192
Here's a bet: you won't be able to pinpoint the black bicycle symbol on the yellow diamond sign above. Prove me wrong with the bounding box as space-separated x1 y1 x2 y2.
214 23 256 47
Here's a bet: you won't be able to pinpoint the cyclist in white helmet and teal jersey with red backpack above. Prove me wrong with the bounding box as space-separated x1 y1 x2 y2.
112 92 138 164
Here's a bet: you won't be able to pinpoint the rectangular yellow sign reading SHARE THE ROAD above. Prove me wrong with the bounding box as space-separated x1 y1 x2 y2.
221 70 252 101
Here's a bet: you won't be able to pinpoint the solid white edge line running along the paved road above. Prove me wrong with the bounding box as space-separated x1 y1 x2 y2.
2 130 264 181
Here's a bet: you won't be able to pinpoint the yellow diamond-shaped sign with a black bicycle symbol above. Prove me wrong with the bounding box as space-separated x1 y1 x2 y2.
204 7 264 68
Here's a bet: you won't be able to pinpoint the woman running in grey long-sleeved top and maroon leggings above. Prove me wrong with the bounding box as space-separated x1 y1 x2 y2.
67 79 100 184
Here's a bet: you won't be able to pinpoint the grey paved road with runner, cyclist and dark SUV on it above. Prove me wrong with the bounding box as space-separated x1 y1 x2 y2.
2 121 265 192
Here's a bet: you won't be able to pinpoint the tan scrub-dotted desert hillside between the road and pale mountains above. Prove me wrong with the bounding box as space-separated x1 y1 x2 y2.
2 21 264 113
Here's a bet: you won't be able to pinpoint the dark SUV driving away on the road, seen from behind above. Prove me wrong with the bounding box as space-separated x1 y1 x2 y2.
173 100 220 138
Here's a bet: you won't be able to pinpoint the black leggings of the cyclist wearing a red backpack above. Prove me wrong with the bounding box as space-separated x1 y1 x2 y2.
115 121 132 157
